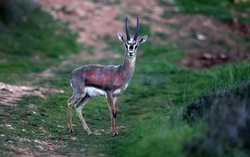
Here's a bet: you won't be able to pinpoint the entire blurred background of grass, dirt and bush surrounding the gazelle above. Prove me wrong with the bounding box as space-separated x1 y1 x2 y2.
0 0 250 157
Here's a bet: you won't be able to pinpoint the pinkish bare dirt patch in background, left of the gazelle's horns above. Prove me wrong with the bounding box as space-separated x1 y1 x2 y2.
37 0 122 49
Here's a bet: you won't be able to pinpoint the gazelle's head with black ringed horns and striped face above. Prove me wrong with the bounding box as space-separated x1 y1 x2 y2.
118 17 147 58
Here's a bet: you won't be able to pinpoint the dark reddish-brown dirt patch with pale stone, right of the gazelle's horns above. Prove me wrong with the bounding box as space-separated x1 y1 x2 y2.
169 15 249 68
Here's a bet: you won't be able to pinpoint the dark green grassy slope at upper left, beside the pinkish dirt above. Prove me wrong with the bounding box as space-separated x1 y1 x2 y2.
0 2 80 82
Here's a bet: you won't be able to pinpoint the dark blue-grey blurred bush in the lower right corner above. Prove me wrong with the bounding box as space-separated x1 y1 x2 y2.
184 84 250 157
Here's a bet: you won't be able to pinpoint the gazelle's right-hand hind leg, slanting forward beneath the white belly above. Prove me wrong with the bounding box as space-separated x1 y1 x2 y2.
76 94 92 135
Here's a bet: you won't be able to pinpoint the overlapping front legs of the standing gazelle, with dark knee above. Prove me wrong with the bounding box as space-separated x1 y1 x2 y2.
107 92 118 136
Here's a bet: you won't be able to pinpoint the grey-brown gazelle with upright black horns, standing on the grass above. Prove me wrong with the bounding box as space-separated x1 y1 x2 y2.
68 17 147 136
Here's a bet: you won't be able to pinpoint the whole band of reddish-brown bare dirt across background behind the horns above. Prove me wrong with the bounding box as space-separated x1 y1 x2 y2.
36 0 249 68
